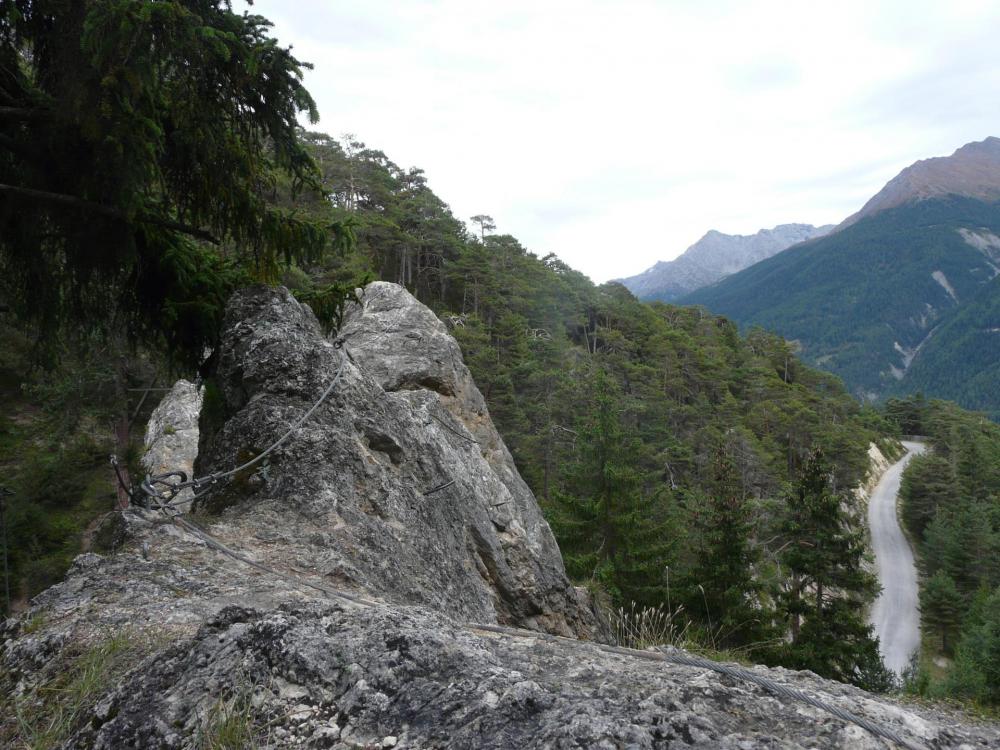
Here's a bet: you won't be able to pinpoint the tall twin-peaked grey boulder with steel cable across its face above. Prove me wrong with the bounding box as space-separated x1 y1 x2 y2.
199 283 601 637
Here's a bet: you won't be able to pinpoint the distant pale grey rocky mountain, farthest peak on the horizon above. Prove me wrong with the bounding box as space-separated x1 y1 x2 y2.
621 224 833 302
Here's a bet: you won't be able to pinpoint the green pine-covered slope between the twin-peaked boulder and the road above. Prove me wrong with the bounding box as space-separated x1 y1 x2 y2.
286 134 896 684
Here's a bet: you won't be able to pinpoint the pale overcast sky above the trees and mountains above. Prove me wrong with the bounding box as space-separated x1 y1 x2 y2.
240 0 1000 282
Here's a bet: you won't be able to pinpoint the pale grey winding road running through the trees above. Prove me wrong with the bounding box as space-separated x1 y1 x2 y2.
868 441 925 674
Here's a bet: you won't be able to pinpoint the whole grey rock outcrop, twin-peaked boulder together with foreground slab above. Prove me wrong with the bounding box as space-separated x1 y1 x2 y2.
0 284 1000 750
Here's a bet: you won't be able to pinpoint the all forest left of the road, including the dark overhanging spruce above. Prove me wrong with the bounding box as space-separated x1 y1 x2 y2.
0 0 908 686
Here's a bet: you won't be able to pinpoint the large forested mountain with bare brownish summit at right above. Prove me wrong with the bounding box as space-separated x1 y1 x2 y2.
681 138 1000 418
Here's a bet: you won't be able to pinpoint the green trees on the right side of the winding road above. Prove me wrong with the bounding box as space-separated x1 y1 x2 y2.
887 396 1000 705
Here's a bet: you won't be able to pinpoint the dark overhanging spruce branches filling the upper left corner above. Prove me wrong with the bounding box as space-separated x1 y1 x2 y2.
0 0 343 361
